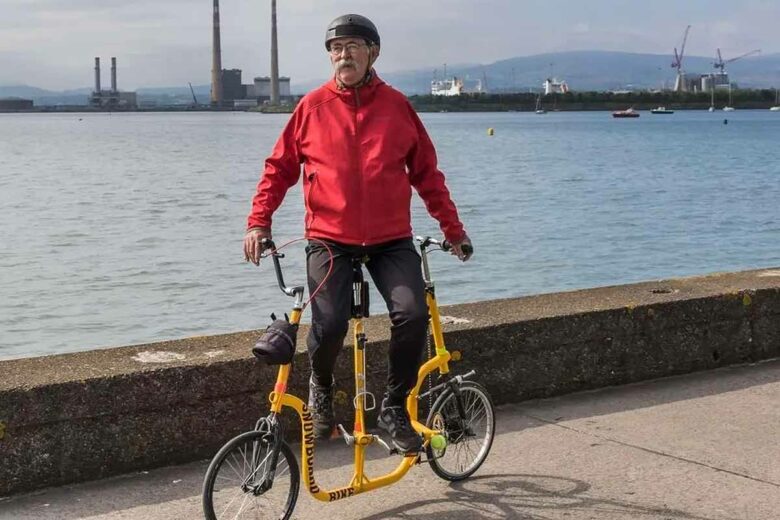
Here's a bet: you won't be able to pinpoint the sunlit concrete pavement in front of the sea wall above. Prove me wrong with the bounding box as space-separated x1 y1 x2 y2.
0 360 780 520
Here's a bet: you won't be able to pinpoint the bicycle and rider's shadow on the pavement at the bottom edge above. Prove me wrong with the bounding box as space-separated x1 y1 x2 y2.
364 474 713 520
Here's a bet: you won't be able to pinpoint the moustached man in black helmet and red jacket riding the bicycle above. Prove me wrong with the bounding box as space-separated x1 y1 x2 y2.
244 14 473 453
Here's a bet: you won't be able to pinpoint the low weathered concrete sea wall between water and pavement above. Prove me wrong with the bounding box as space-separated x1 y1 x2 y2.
0 268 780 496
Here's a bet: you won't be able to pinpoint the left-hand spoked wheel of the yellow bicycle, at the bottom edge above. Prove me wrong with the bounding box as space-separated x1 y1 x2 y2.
203 431 300 520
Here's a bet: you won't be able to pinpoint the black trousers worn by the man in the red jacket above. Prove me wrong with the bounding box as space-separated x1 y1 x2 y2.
306 238 428 405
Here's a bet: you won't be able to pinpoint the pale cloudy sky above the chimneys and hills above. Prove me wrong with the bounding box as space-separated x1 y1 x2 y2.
0 0 780 90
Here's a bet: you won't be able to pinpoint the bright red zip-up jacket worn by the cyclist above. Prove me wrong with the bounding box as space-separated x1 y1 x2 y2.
248 74 464 245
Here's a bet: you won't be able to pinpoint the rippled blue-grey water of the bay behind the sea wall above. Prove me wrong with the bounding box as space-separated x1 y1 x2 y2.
0 111 780 358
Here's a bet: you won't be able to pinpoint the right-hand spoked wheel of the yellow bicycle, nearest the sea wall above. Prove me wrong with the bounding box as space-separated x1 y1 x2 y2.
427 381 496 481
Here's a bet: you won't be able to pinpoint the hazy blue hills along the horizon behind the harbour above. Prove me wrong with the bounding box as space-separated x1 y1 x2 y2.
7 51 780 105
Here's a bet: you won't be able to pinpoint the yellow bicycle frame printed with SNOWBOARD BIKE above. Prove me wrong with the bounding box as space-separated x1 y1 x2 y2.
269 286 451 502
